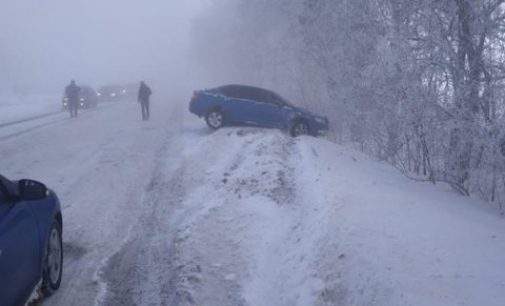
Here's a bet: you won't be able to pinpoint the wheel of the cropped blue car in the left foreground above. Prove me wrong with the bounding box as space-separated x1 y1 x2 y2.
42 221 63 296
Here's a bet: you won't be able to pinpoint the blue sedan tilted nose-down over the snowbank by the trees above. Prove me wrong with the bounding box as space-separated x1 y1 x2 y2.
189 85 328 137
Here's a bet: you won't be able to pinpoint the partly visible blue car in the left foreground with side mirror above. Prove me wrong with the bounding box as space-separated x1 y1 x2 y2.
0 175 63 306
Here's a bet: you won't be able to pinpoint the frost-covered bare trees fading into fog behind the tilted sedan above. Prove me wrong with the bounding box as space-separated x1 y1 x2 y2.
194 0 505 210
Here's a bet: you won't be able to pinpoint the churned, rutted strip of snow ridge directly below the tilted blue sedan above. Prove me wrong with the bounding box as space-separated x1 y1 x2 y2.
165 129 311 306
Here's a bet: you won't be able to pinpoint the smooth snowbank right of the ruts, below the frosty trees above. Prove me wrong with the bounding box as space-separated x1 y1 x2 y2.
298 138 505 305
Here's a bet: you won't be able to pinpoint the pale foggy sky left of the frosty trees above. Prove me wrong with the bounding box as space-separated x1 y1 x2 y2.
0 0 202 93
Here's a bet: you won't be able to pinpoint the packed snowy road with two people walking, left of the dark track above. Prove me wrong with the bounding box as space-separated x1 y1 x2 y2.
0 103 185 305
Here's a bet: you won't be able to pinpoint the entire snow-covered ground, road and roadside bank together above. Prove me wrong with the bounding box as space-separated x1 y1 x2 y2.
0 99 505 306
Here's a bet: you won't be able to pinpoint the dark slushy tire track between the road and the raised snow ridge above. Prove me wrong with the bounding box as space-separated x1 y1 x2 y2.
98 118 184 305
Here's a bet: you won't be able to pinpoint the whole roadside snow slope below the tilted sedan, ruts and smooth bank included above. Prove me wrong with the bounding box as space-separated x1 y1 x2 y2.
168 125 505 306
